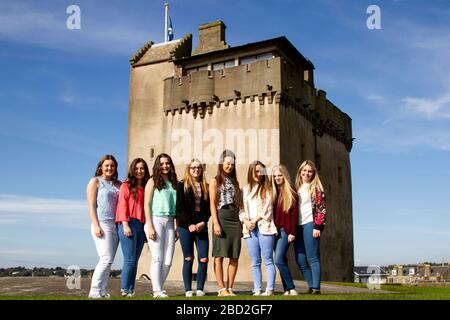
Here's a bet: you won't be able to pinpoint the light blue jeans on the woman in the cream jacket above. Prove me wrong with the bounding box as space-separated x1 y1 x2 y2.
245 226 276 291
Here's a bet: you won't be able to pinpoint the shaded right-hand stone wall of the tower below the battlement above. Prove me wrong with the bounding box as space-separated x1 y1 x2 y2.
280 101 353 281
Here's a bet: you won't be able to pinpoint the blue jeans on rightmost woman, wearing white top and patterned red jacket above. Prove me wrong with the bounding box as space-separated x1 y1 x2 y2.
294 222 321 289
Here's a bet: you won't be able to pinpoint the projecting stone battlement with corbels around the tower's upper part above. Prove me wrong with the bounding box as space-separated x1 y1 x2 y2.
163 56 353 151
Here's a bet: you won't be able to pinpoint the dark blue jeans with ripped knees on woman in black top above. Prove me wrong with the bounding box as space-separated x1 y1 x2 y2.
178 226 209 291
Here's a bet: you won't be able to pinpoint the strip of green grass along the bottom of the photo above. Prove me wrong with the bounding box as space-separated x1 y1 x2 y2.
0 282 450 301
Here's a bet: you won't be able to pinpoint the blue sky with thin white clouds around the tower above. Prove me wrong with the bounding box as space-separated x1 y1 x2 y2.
0 0 450 268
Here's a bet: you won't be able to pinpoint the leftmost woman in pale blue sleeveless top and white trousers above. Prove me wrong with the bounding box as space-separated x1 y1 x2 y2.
86 155 121 299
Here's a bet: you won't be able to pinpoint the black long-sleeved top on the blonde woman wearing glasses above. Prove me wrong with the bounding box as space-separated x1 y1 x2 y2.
177 181 211 229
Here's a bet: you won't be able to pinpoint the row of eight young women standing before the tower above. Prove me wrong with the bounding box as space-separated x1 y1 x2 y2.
87 150 326 298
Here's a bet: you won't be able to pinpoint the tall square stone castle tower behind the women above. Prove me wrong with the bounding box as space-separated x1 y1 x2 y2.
128 21 353 281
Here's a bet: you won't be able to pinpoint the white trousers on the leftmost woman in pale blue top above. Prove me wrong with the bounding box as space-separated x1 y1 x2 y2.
89 220 119 298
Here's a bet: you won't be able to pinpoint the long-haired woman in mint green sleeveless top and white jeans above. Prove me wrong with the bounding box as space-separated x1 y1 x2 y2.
144 153 178 298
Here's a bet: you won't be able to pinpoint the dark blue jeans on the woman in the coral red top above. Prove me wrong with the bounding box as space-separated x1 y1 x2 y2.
119 219 145 293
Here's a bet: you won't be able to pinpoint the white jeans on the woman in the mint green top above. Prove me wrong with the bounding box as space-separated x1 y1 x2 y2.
144 216 175 292
